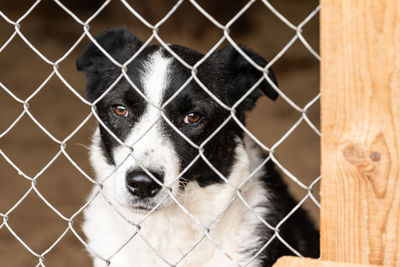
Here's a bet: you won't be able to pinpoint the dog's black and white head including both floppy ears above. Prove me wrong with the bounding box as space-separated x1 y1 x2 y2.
77 28 278 210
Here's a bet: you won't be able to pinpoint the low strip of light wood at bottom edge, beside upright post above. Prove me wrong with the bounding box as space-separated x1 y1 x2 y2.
273 257 382 267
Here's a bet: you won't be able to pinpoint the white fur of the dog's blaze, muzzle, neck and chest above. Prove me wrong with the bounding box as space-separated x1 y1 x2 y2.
83 49 268 267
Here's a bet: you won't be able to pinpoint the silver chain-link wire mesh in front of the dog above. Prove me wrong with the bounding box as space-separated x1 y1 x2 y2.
0 0 321 266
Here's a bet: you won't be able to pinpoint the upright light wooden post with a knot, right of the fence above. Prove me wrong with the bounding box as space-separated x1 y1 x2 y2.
321 0 400 266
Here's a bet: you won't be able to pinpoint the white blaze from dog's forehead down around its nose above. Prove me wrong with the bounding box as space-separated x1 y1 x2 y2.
114 51 179 202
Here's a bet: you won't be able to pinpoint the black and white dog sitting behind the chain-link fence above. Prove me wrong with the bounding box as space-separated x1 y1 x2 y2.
77 28 319 267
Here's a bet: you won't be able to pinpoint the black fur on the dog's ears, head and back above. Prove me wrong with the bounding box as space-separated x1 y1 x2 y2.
77 28 319 266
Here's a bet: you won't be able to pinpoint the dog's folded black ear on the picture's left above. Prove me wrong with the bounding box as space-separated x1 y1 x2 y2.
76 27 142 102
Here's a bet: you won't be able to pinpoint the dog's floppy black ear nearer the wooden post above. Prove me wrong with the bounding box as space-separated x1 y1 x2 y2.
212 45 278 119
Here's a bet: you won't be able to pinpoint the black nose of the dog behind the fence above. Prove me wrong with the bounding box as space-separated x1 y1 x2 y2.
126 171 162 198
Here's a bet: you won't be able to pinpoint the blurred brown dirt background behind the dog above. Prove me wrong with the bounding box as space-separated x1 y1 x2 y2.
0 0 320 267
